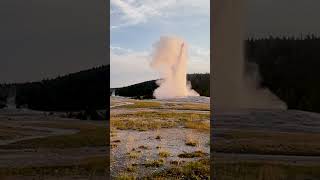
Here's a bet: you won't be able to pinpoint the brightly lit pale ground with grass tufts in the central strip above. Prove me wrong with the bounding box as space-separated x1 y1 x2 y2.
110 97 210 179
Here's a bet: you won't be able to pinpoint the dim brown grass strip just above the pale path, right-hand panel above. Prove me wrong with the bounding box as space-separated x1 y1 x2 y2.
214 130 320 156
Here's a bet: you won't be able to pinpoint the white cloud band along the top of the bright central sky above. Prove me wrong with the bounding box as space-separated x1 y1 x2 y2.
111 0 210 29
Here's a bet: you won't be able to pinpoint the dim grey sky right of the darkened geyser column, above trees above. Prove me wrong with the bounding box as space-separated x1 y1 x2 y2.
247 0 320 36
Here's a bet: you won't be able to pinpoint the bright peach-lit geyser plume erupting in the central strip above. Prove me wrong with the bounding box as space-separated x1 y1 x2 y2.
151 37 199 99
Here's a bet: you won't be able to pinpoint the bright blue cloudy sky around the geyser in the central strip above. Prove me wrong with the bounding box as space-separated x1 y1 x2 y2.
110 0 210 87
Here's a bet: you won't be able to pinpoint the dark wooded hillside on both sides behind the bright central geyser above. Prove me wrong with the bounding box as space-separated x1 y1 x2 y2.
110 74 210 99
